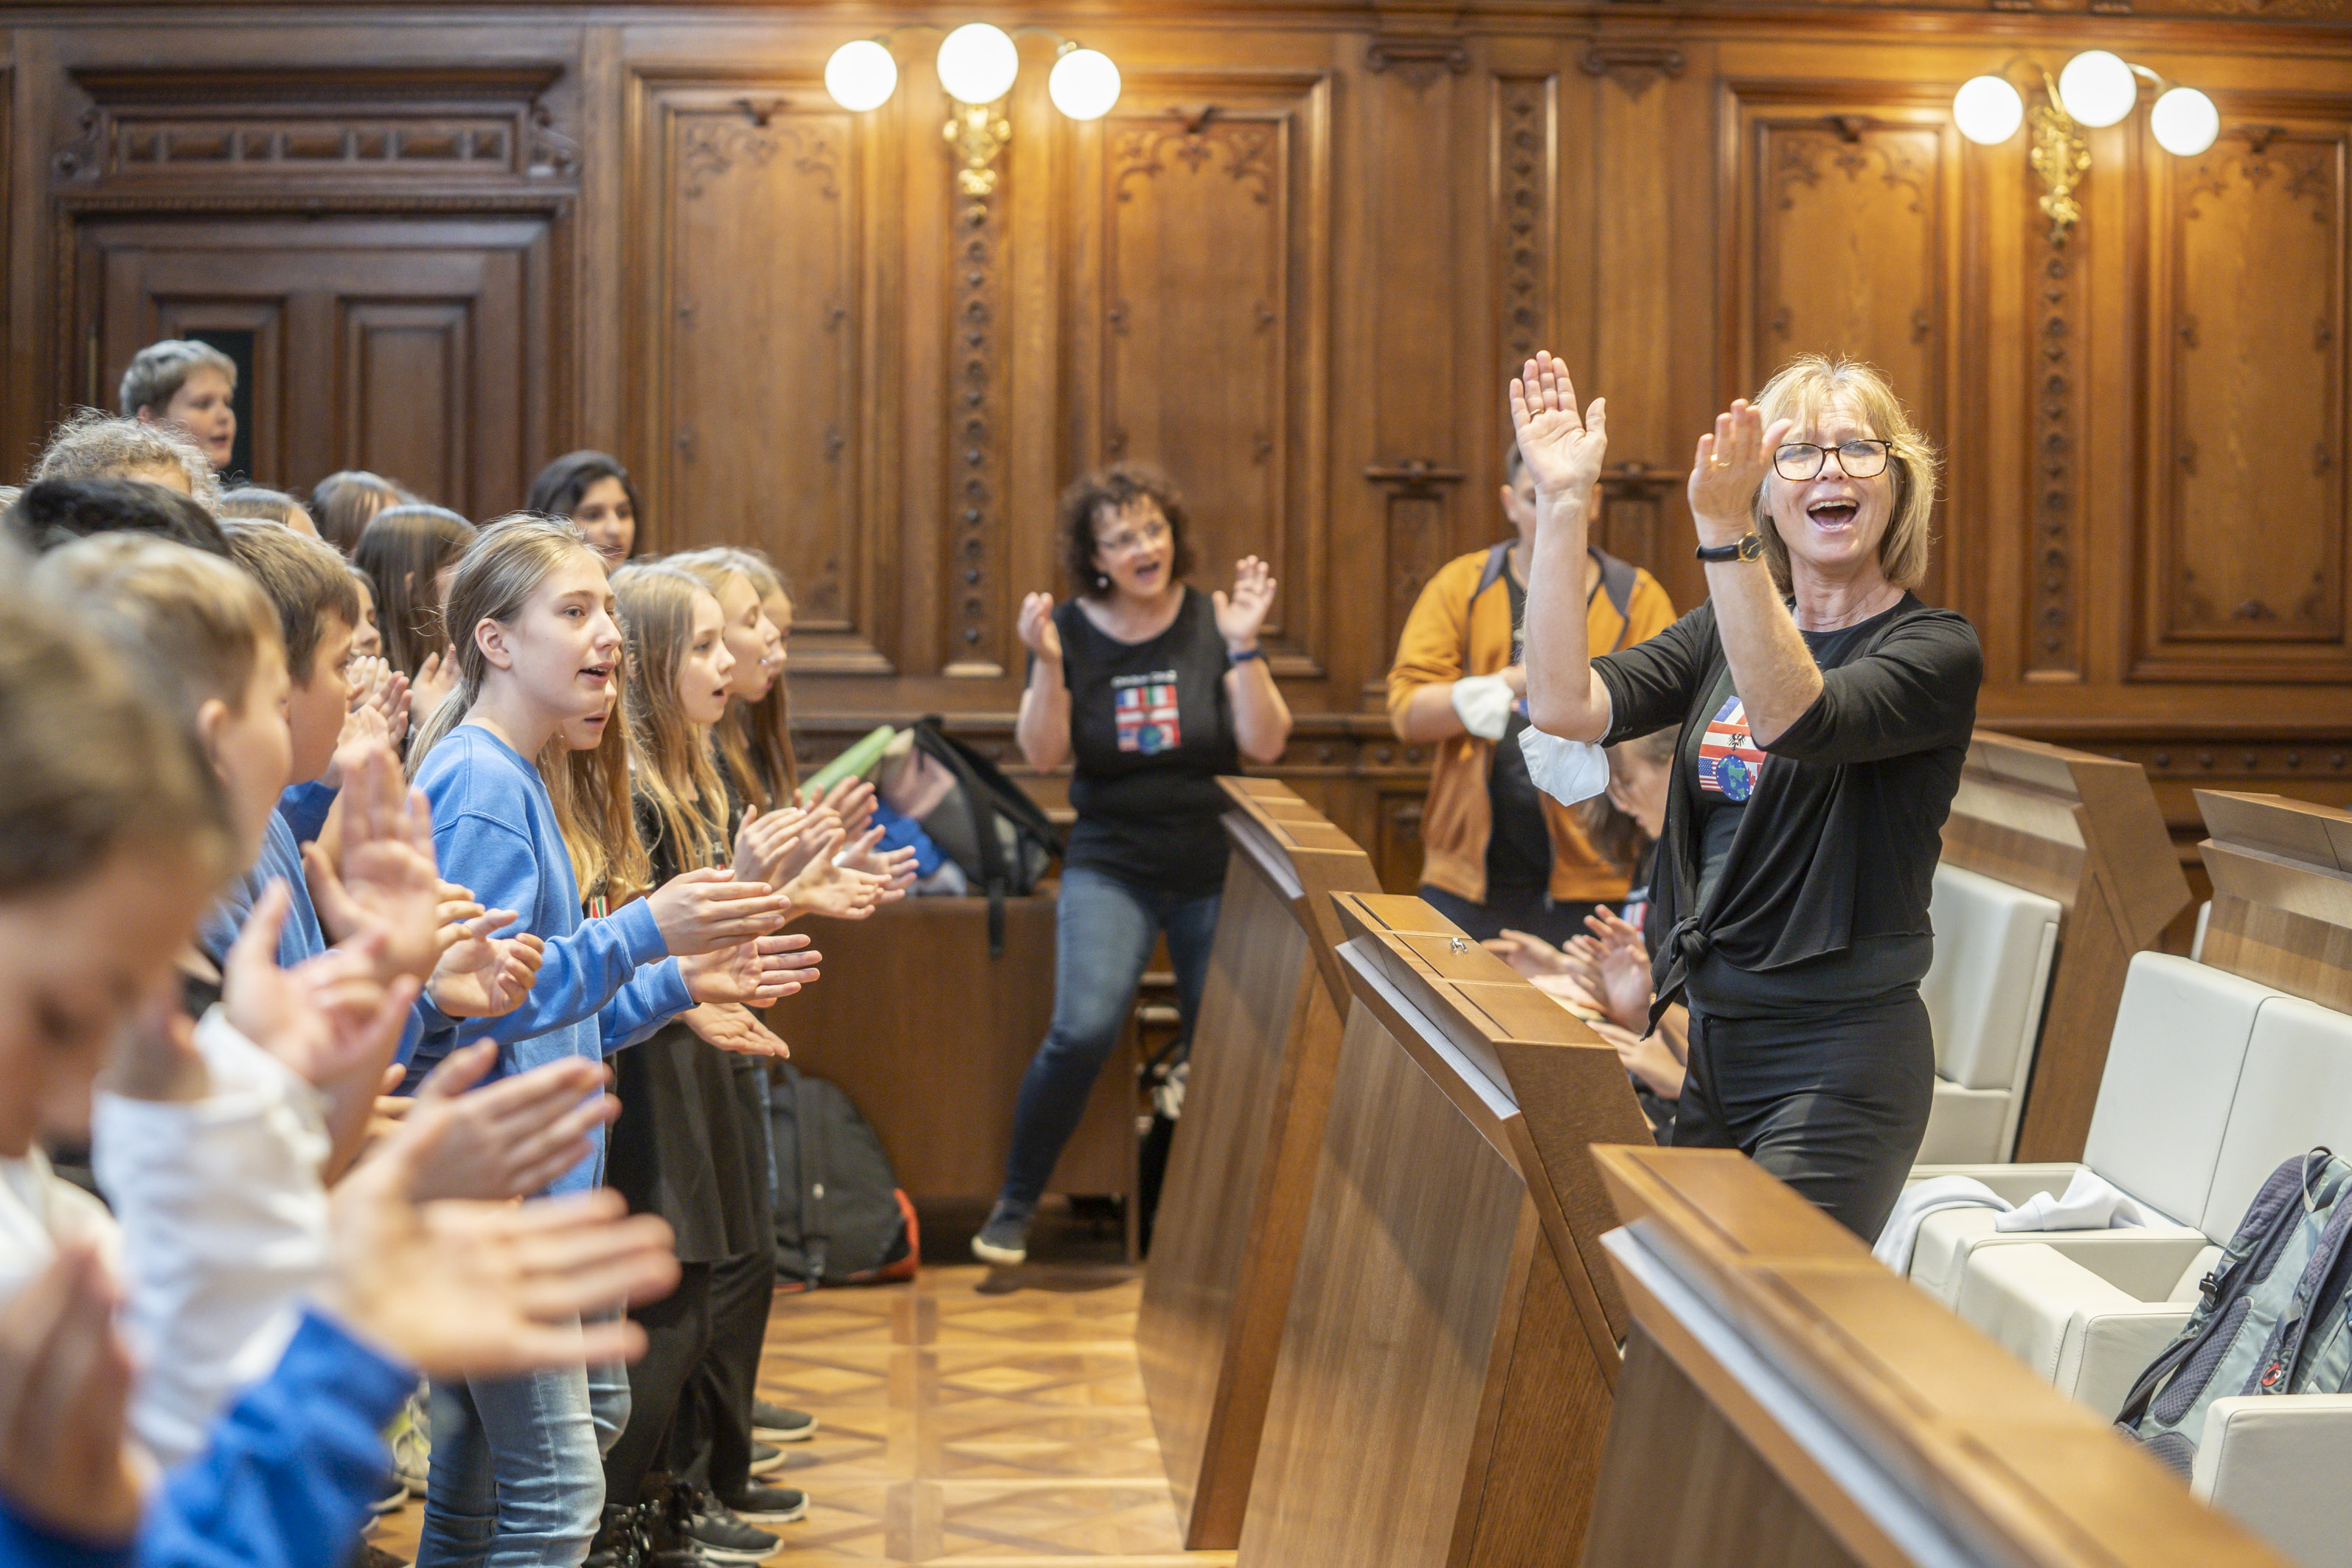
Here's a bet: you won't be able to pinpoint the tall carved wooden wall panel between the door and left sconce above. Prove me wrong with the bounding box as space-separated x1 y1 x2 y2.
635 80 889 670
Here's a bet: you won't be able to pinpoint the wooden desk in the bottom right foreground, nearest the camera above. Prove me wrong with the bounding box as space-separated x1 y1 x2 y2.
1585 1147 2281 1568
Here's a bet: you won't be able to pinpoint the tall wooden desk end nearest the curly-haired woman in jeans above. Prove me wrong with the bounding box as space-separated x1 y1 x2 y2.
1136 780 1376 1550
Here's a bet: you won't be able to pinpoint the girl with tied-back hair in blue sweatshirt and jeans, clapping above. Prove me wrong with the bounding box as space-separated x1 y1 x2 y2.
409 517 802 1568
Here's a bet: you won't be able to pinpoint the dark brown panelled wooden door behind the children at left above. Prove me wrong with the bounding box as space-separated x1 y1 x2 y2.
66 214 555 519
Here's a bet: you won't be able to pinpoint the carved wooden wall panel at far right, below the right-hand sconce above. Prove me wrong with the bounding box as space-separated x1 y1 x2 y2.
2136 103 2352 679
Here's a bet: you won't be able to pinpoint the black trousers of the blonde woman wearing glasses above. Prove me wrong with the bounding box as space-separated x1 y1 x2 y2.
1675 990 1936 1241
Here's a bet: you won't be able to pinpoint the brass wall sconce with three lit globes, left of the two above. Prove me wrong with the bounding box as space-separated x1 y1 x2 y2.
825 21 1120 198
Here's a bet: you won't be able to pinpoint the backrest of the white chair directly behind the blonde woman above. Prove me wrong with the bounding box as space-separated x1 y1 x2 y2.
1919 865 2063 1105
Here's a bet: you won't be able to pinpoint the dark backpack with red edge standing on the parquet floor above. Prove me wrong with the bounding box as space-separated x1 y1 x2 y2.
767 1063 922 1291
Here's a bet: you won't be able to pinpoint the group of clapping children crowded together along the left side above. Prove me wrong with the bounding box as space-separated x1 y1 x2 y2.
0 355 915 1568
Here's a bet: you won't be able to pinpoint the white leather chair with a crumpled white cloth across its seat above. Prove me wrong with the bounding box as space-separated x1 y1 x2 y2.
1909 952 2281 1307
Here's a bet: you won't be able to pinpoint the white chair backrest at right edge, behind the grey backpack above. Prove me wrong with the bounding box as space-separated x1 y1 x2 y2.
2197 996 2352 1241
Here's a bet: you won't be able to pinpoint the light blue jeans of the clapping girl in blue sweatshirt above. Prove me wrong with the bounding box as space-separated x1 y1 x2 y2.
416 1335 628 1568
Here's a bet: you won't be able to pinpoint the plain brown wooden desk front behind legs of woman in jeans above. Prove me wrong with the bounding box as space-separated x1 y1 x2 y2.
769 898 1136 1199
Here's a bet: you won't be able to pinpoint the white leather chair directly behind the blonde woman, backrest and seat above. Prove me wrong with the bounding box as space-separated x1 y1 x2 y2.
1919 865 2063 1164
